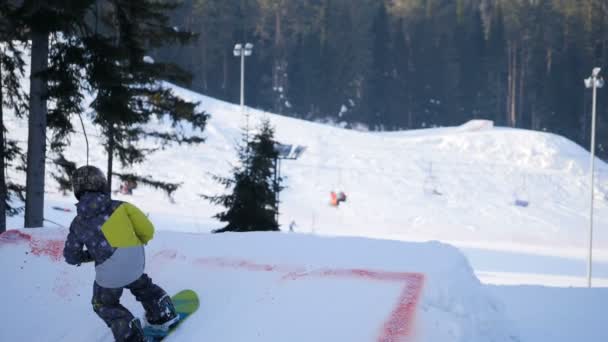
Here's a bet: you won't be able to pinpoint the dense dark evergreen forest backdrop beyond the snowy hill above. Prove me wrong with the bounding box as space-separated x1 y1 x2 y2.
10 0 608 159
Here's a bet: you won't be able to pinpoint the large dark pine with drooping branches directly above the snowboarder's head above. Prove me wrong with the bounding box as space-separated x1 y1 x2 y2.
83 0 208 189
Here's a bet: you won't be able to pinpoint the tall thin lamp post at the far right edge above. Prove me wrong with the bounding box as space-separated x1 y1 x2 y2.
585 68 604 287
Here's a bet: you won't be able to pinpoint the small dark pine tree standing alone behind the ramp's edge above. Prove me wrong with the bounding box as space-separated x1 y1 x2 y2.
203 120 281 233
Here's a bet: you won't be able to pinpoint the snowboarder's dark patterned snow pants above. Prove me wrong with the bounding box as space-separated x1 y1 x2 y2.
92 273 172 342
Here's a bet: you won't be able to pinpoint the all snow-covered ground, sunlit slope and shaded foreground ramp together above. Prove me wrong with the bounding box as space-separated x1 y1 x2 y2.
0 79 608 342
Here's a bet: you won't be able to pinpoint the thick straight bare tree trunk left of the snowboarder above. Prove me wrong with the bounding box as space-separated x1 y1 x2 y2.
25 32 49 228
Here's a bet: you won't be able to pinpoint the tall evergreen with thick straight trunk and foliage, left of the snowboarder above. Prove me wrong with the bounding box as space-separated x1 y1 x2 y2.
12 0 93 227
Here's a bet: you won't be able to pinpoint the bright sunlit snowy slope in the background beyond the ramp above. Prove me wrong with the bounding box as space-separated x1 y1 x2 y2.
9 83 608 261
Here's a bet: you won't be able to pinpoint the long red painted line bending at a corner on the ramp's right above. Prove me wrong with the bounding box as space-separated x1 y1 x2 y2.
195 258 424 342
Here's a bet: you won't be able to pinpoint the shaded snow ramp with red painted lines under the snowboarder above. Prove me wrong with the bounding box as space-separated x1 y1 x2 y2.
0 229 518 342
